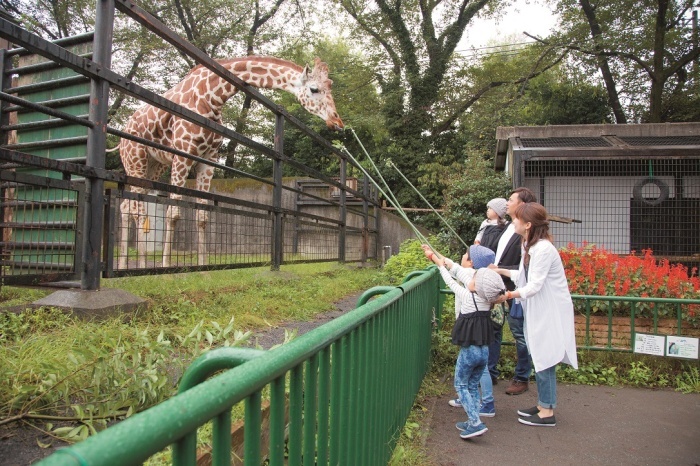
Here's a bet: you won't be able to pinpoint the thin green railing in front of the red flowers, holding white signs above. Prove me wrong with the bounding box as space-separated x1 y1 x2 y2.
571 295 700 353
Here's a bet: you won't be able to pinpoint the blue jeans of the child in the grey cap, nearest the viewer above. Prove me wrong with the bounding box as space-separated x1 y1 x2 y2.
455 345 489 426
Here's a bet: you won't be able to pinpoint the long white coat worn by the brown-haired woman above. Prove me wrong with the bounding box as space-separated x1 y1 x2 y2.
511 240 578 372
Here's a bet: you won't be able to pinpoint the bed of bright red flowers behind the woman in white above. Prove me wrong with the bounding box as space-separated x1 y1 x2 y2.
559 243 700 325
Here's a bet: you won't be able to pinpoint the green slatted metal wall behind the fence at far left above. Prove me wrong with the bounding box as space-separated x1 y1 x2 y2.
0 34 93 276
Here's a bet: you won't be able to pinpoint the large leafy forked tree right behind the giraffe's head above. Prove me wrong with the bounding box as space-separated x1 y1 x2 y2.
326 0 562 206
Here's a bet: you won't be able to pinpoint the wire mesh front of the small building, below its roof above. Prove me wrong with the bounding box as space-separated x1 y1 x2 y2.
524 157 700 274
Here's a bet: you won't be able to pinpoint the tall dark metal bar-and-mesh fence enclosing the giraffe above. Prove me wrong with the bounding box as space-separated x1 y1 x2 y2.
0 0 379 289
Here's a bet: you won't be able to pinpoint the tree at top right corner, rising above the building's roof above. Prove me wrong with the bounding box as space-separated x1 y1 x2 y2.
542 0 700 123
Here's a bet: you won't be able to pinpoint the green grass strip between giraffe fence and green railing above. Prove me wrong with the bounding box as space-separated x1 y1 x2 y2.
0 263 382 448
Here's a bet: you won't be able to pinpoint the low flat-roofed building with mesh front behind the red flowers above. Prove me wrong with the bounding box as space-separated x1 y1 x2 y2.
495 123 700 267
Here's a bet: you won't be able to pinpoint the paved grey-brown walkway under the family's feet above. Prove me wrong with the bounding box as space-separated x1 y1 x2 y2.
426 381 700 466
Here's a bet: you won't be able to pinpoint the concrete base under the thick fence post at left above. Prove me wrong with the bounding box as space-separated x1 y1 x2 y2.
32 288 148 319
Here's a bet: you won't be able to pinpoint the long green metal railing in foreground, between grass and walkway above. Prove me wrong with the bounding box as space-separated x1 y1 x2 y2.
39 267 442 466
